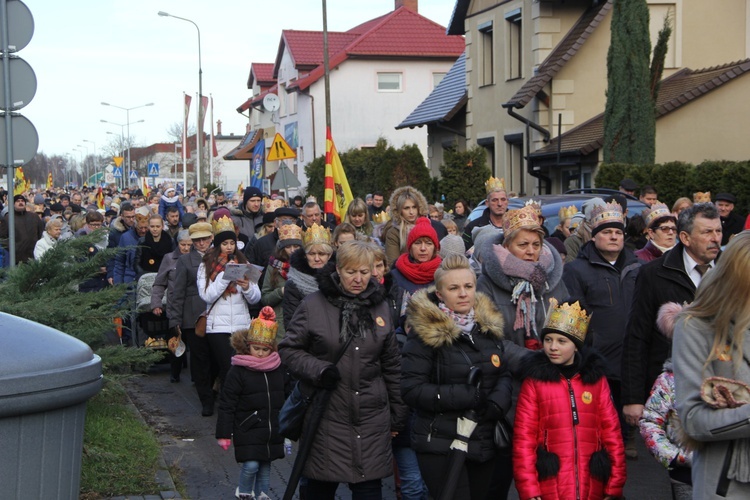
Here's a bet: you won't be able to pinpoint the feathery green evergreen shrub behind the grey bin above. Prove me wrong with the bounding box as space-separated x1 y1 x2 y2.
0 229 162 373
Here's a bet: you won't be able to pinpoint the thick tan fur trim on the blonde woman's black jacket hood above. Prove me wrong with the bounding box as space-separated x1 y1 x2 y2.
406 287 505 349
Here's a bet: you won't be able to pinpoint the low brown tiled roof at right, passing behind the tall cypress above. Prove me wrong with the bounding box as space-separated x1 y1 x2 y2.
531 59 750 157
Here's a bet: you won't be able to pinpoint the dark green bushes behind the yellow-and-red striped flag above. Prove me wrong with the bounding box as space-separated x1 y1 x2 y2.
305 138 431 205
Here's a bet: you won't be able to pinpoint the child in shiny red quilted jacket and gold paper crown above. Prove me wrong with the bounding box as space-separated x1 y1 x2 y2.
513 299 626 500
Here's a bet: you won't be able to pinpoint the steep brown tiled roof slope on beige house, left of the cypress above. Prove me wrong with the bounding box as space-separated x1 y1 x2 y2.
504 0 612 108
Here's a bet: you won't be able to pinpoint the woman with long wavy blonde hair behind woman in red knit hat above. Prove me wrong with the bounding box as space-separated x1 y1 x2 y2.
381 186 432 267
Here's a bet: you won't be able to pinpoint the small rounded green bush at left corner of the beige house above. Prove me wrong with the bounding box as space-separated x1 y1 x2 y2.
439 146 491 207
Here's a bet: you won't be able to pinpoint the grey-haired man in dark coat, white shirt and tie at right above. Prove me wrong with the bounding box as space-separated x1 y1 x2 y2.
622 203 721 432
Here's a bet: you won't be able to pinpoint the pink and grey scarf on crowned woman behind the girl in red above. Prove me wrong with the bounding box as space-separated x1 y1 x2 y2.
492 245 555 349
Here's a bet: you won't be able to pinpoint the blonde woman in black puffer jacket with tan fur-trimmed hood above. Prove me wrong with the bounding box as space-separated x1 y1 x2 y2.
401 254 511 500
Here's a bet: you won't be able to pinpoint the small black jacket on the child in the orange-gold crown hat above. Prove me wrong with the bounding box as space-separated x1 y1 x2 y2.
216 365 284 462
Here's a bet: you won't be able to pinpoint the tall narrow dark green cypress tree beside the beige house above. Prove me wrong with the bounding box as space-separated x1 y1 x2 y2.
604 0 656 164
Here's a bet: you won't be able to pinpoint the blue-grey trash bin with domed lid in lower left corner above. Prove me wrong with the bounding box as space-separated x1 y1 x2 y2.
0 313 103 499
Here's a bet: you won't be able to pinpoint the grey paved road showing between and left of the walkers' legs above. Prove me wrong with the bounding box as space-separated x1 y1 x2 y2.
127 365 671 500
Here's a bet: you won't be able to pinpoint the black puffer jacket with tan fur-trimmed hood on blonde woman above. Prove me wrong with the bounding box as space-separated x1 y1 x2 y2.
401 289 512 462
